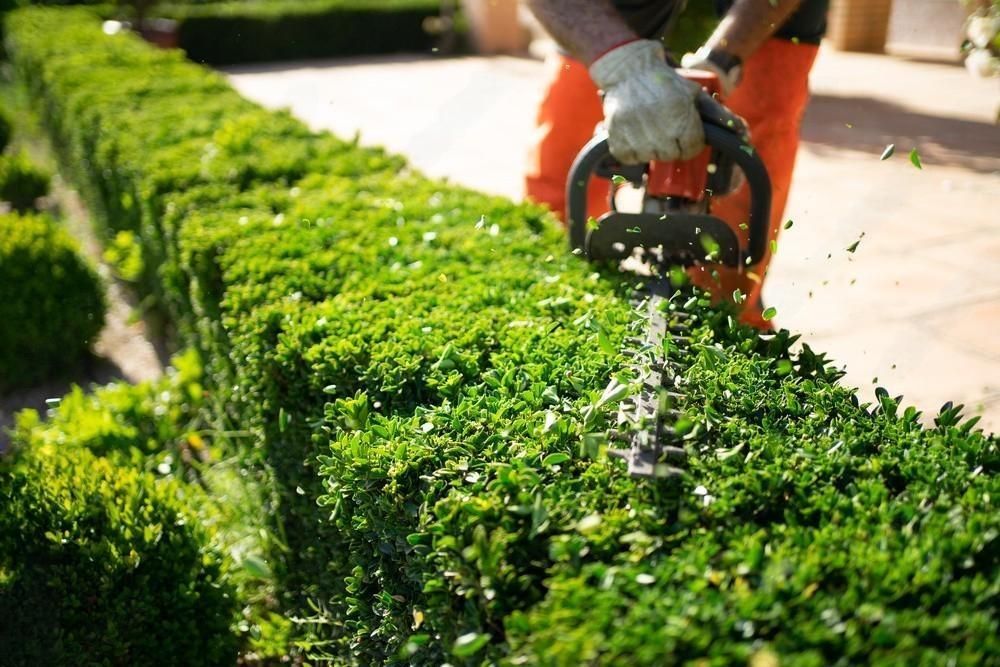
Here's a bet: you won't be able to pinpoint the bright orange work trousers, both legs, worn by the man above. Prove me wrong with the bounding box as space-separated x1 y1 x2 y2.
525 38 818 329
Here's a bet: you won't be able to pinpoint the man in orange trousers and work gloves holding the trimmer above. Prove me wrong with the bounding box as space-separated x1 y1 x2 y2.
526 0 828 329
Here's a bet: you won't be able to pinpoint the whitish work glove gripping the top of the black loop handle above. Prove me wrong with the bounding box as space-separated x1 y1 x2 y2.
590 39 705 164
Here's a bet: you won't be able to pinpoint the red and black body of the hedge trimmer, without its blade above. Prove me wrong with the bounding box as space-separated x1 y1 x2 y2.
566 70 771 268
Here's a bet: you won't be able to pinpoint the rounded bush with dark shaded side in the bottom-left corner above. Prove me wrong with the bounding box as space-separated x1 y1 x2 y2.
0 444 236 666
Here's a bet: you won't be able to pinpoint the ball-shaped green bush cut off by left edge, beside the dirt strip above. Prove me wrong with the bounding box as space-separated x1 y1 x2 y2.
0 214 106 389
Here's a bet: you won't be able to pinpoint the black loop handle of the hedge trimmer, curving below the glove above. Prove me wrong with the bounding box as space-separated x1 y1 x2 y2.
566 119 771 267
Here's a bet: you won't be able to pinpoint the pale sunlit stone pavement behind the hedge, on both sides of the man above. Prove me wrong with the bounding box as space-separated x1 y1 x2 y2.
230 50 1000 431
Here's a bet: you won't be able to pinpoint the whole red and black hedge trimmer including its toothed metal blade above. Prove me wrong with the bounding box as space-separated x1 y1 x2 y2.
567 71 771 477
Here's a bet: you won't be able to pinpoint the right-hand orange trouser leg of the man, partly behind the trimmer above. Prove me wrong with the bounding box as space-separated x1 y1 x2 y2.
692 38 818 329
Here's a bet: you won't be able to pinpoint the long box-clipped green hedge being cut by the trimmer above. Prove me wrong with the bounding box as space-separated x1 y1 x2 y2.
10 10 1000 664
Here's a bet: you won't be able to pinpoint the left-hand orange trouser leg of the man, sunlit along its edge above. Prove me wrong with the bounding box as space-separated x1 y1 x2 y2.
525 56 609 220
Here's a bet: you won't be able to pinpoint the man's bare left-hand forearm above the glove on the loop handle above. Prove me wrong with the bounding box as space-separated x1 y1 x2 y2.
527 0 636 65
